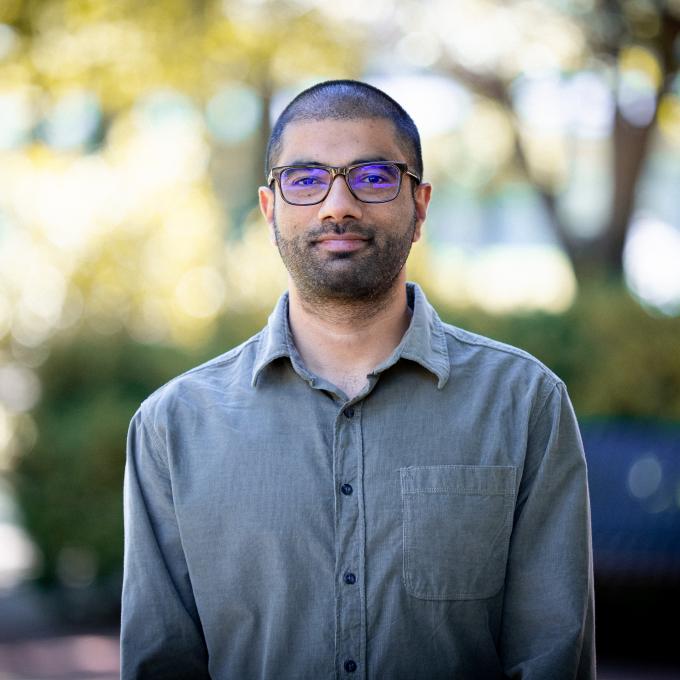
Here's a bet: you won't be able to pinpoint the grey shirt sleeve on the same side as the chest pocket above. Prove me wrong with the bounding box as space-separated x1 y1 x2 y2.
500 383 595 680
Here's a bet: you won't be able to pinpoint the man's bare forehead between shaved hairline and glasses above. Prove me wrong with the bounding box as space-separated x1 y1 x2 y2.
276 118 407 166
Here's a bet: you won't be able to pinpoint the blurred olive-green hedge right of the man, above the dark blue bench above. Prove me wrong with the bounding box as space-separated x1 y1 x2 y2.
442 283 680 420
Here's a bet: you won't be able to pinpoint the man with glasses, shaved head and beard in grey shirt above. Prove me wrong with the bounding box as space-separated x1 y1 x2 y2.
122 81 594 680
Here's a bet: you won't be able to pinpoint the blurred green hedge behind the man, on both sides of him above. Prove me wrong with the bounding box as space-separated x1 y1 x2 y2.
15 286 680 583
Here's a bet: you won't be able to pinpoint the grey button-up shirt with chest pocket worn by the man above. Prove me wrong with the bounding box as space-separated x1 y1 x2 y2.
121 284 594 680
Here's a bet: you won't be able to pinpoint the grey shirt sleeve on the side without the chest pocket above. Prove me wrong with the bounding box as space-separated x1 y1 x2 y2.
121 410 210 680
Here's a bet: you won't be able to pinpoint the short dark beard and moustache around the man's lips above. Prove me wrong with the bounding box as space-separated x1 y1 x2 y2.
274 210 416 303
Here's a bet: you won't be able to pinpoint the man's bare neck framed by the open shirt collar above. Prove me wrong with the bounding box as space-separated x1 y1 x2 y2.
288 276 411 398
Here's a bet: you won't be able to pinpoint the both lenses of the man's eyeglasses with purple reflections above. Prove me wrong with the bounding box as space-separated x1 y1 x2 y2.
279 163 401 205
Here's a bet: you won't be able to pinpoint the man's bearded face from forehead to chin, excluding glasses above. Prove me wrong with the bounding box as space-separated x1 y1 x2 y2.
260 119 430 301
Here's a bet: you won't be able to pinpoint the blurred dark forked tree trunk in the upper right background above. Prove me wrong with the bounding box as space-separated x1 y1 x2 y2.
432 0 680 278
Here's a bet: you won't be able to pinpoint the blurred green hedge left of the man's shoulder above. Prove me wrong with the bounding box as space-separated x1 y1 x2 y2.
13 315 262 585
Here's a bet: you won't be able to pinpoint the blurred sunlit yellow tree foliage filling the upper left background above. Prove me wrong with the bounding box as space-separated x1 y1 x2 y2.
0 0 363 346
